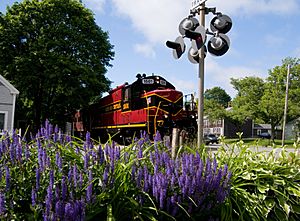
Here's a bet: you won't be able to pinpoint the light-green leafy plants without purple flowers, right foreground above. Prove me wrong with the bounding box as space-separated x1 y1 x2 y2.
215 136 300 221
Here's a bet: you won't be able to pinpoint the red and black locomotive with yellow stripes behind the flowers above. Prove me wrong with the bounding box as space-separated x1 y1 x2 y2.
74 74 196 141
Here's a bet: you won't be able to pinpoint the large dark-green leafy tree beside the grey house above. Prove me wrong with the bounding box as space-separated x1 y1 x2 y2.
0 0 114 127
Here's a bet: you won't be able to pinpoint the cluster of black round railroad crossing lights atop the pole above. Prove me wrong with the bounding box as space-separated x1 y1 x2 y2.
166 5 232 64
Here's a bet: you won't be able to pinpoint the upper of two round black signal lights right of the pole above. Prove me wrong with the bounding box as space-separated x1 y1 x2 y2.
210 14 232 34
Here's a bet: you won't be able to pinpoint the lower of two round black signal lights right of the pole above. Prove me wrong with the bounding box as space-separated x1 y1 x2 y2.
207 34 230 56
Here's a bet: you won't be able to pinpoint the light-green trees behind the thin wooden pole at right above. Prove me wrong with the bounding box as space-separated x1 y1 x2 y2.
228 58 300 138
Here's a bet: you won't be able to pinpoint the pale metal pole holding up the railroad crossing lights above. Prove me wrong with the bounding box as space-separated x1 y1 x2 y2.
197 2 205 149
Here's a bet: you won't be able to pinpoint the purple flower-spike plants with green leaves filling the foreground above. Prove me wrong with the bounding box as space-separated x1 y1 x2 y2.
0 122 231 220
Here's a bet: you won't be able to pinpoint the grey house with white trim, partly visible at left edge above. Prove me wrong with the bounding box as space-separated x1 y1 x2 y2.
0 75 19 133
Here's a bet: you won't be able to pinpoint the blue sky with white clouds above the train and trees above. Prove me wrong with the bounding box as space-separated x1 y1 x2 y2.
0 0 300 97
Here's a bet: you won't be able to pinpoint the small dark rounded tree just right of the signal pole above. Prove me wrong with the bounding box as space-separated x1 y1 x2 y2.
204 87 231 108
